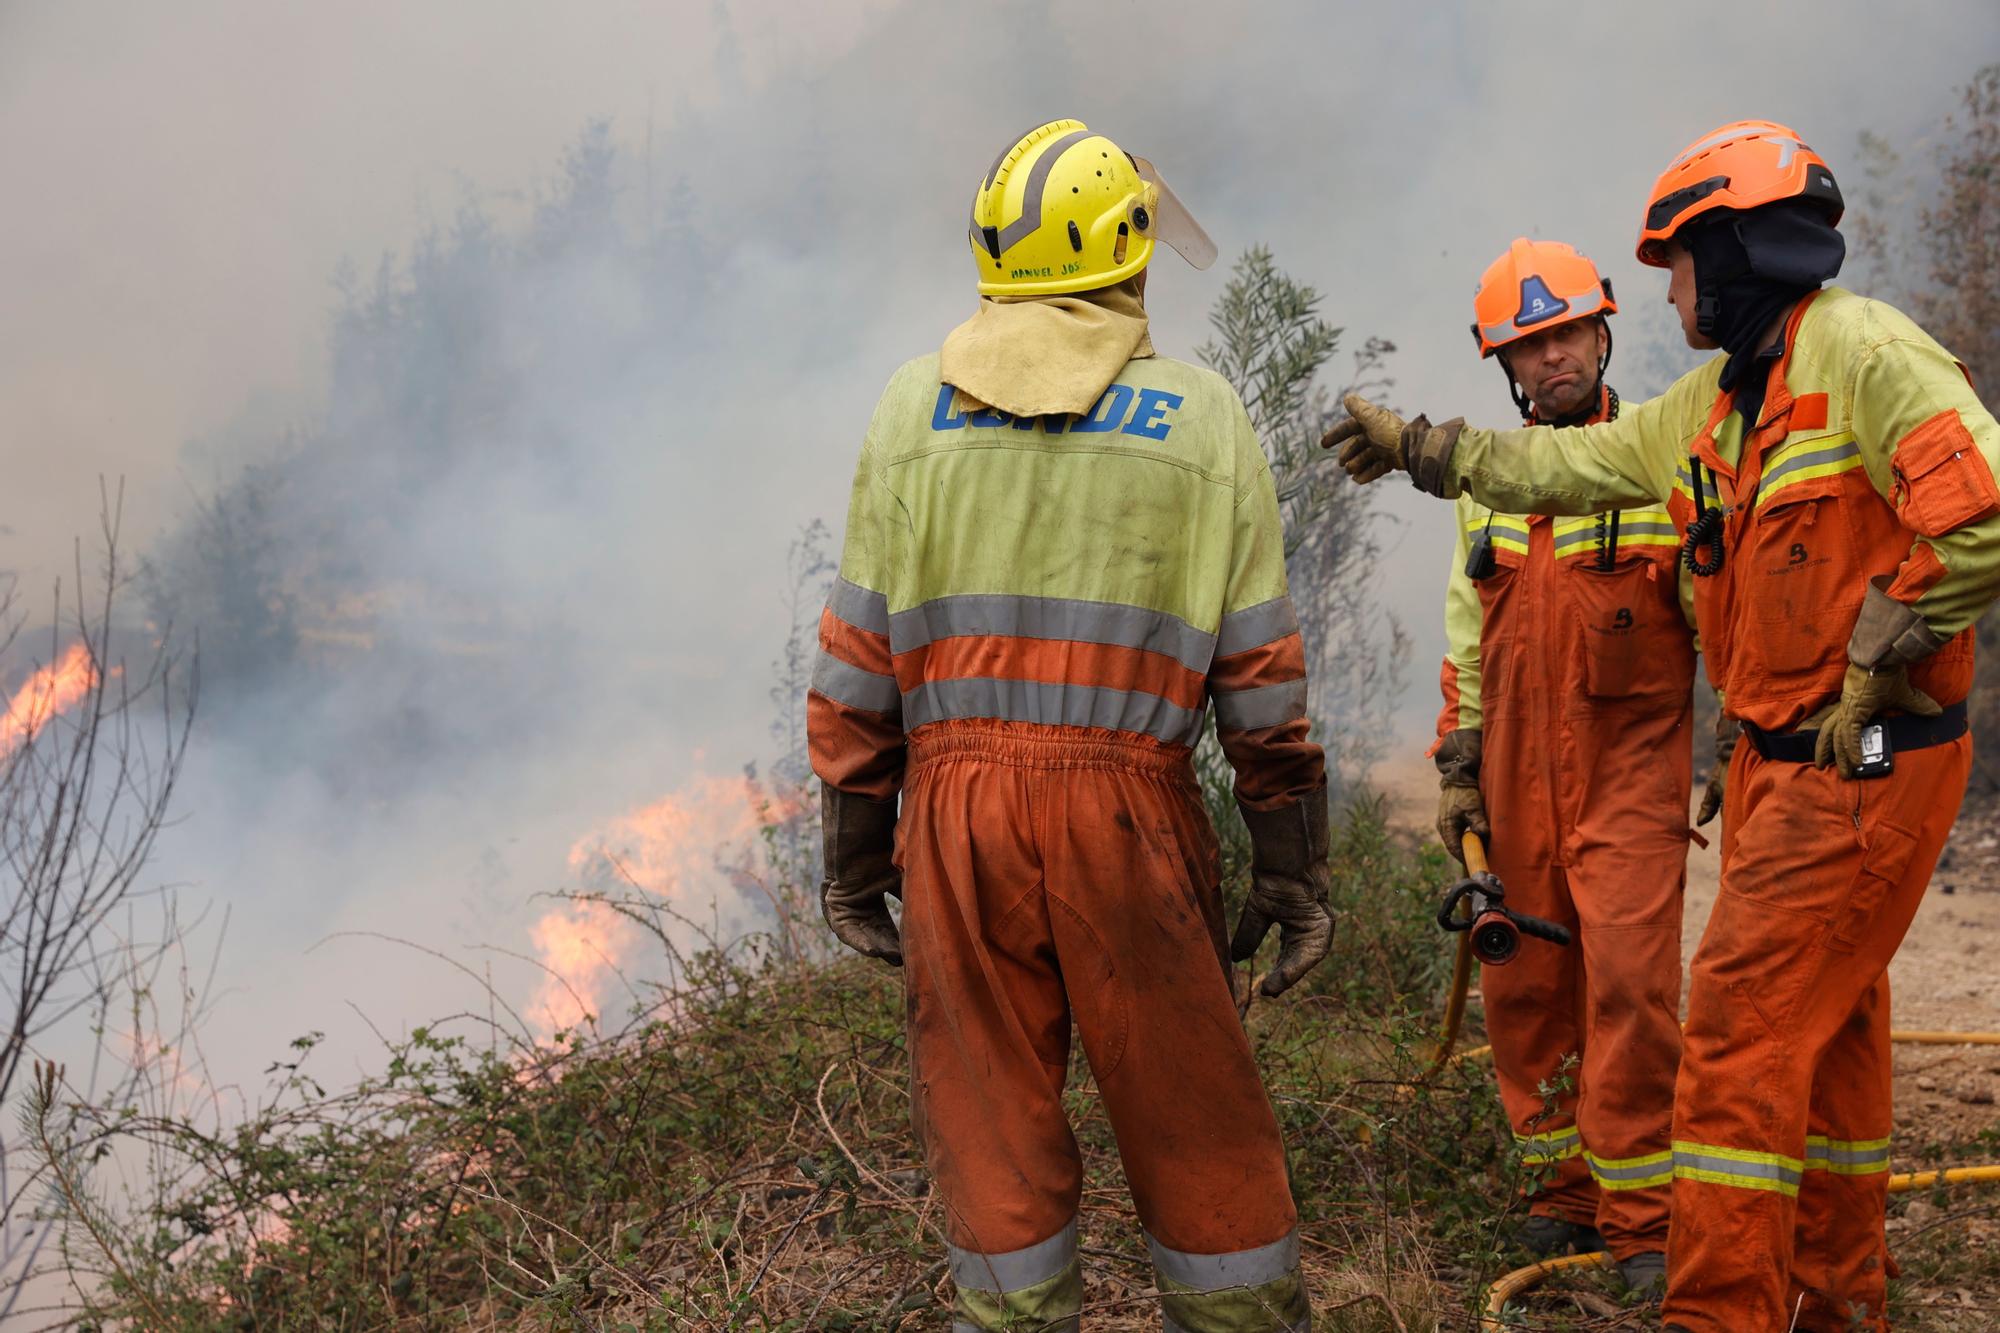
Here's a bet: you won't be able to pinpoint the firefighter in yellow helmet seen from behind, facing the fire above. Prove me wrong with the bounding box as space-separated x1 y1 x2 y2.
808 120 1334 1333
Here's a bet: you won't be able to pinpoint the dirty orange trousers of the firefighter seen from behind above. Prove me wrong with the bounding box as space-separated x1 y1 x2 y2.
896 721 1310 1331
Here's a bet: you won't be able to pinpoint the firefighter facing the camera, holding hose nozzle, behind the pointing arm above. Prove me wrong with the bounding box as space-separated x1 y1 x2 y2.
1432 238 1694 1295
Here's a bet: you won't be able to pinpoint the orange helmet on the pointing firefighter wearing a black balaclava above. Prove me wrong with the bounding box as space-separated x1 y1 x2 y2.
1638 120 1844 268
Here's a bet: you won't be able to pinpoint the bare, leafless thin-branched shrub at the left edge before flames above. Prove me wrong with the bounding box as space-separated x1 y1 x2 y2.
0 496 194 1323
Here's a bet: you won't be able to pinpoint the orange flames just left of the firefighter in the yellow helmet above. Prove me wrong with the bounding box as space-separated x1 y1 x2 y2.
528 775 798 1033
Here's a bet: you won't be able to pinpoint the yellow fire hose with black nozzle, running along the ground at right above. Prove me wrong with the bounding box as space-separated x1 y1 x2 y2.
1422 833 2000 1329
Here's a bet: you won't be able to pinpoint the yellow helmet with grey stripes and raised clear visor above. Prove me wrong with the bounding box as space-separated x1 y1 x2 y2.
970 120 1216 296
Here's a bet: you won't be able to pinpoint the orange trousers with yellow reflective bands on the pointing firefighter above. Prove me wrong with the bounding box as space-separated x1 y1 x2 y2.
1664 737 1972 1333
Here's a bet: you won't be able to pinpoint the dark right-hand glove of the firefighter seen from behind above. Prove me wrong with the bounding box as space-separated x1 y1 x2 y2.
1230 791 1334 999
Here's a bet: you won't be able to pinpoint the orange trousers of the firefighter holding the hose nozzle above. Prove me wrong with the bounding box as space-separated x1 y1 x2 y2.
1480 703 1692 1259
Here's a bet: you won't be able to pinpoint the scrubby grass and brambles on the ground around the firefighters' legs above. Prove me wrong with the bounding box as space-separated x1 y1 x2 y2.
30 805 2000 1333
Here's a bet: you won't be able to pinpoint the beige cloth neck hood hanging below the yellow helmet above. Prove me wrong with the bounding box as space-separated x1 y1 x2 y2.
938 276 1152 416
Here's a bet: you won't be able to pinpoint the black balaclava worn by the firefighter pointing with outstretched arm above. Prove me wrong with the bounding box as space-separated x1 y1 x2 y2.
1682 198 1848 428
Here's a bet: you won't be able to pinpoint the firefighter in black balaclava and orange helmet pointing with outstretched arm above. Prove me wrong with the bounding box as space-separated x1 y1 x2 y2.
1328 120 2000 1333
